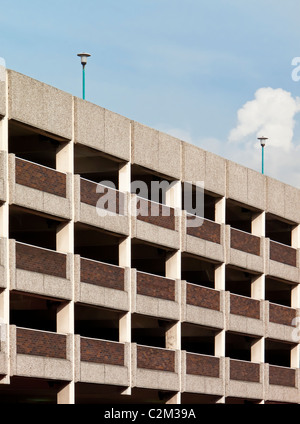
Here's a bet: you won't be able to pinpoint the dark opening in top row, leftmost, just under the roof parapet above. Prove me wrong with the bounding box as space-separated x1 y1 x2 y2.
8 121 66 169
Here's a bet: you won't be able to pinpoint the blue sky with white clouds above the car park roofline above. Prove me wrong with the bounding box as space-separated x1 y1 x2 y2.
0 0 300 187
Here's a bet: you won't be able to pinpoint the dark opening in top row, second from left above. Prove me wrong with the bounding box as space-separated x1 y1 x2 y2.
74 144 123 190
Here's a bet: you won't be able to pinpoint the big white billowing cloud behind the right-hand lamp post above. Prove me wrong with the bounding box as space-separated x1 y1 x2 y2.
159 87 300 188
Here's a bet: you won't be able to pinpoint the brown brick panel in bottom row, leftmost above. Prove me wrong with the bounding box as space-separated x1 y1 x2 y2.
17 328 67 359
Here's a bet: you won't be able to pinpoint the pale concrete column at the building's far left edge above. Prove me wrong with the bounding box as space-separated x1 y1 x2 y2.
0 69 10 384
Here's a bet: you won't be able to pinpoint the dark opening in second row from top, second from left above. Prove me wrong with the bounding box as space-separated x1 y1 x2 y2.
74 223 123 266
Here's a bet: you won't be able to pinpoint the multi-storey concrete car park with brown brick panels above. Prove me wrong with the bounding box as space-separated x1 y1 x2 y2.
0 70 300 404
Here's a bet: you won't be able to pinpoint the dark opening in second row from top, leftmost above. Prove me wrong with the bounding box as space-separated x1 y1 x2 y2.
9 205 67 250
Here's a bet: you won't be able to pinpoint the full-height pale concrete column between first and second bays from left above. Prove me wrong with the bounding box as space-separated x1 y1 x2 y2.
56 99 76 405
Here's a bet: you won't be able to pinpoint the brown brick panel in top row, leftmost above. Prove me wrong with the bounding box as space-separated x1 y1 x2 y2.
15 158 67 198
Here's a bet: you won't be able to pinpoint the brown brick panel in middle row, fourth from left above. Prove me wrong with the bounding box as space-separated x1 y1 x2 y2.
186 283 220 311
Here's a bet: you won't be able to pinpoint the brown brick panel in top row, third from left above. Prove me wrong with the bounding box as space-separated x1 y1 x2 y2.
137 199 175 231
